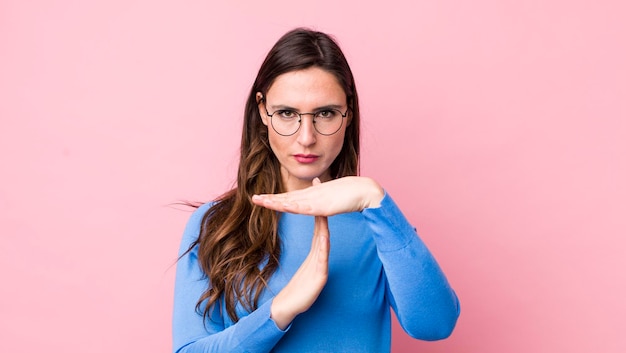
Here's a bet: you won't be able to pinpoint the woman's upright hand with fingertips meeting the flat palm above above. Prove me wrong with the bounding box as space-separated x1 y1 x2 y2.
270 180 330 330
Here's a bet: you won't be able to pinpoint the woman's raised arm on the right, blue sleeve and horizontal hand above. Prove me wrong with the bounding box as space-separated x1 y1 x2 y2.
252 177 460 340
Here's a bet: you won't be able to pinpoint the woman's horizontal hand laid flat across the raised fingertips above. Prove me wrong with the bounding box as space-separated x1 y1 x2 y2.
252 176 385 216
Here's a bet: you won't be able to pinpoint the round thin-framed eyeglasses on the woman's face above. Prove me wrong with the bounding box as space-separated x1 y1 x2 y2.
261 98 350 136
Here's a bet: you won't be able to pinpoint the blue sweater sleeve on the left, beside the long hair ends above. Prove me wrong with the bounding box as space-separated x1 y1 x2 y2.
172 204 286 353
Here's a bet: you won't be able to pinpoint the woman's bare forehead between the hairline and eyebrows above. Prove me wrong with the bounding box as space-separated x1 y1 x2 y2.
266 67 346 107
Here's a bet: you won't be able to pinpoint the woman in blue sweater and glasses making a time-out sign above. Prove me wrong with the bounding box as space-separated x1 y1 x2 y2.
173 29 459 352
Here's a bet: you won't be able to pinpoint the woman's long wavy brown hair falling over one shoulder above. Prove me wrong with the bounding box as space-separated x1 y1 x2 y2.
190 28 359 321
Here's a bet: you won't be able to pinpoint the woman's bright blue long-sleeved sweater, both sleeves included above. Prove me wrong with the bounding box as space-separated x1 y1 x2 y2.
173 194 460 353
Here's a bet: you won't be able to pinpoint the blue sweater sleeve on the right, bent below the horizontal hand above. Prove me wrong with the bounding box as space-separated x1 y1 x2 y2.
362 192 460 340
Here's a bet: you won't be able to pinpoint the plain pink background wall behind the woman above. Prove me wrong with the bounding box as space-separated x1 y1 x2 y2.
0 0 626 353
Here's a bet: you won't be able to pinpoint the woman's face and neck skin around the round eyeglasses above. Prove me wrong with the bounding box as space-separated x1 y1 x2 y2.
257 67 350 191
